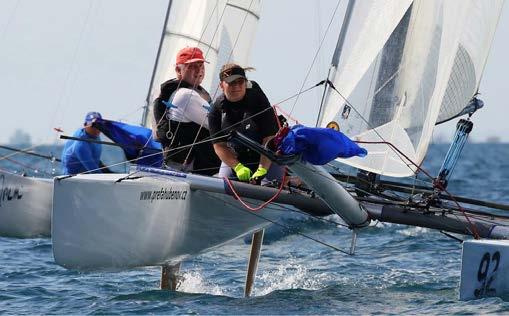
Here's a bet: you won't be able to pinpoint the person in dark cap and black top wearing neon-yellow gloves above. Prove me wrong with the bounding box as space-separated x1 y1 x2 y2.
209 64 284 184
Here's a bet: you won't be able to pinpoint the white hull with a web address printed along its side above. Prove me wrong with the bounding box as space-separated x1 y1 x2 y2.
52 170 283 269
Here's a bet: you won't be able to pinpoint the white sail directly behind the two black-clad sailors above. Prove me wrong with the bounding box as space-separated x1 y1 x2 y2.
142 0 261 127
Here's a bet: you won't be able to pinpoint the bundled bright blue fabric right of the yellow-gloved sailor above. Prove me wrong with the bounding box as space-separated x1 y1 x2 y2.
278 125 368 165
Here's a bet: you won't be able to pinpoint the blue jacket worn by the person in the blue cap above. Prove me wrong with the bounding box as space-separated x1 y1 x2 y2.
62 128 101 174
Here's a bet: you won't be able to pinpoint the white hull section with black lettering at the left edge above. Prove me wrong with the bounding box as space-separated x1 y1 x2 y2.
0 170 53 238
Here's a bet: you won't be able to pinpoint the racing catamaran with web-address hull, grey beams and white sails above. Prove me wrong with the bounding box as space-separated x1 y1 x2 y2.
52 0 509 297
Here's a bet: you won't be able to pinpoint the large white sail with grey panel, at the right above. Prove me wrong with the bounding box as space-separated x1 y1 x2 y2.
318 0 503 177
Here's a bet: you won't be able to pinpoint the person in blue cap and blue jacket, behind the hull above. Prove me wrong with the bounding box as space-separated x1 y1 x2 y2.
62 112 111 174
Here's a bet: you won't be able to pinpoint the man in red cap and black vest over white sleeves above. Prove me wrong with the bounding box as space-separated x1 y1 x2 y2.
154 47 220 175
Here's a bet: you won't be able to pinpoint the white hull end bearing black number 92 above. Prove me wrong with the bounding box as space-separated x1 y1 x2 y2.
460 240 509 300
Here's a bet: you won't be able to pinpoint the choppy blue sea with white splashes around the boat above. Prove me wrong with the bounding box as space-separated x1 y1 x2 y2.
0 144 509 314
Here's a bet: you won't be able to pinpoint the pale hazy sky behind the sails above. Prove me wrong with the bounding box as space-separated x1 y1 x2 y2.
0 0 509 143
